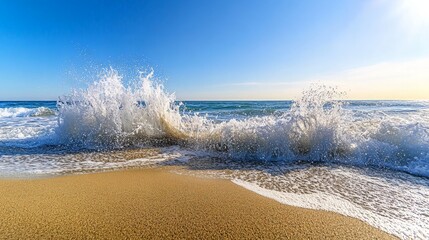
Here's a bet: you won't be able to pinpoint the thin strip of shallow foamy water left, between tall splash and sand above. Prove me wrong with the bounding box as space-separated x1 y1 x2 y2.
0 146 188 178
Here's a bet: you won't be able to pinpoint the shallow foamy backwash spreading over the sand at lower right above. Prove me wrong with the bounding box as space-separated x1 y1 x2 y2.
170 157 429 239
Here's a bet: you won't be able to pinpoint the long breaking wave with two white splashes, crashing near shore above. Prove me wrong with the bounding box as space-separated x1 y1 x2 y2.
57 69 429 177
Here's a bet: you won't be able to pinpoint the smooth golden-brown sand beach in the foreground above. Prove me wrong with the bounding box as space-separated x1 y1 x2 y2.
0 168 393 239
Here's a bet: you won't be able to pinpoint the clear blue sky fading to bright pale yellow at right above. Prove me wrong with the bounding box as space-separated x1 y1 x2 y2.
0 0 429 100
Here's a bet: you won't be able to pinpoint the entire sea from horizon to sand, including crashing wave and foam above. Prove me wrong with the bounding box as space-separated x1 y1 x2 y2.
0 71 429 239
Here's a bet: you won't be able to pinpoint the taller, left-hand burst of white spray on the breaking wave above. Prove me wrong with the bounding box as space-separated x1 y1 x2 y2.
58 69 199 147
